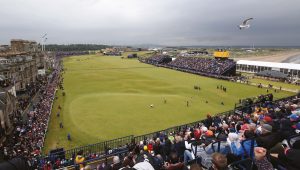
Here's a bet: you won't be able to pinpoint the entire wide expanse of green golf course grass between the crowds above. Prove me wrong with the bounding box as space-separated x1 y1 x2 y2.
44 55 292 151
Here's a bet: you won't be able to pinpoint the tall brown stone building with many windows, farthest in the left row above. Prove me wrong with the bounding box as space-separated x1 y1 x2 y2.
0 39 46 92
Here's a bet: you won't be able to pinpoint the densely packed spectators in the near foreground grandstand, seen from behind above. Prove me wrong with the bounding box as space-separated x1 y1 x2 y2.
41 95 300 170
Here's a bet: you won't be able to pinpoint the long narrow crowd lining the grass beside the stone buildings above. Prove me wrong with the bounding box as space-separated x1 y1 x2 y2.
1 58 60 166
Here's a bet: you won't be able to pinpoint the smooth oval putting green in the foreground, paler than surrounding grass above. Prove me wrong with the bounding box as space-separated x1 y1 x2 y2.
69 93 192 140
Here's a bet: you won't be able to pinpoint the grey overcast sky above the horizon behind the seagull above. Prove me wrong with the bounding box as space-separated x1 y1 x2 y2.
0 0 300 46
